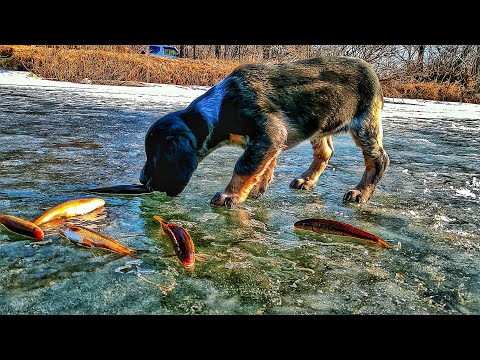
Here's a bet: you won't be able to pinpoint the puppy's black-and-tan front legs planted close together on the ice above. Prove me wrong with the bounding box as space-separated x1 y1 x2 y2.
210 114 287 207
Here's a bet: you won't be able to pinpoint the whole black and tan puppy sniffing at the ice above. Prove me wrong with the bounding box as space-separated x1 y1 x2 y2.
140 57 389 206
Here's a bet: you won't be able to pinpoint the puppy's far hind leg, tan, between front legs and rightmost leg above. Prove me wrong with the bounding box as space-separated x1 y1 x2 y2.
290 135 333 190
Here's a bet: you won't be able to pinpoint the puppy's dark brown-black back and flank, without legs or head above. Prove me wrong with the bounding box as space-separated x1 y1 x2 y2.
226 57 383 140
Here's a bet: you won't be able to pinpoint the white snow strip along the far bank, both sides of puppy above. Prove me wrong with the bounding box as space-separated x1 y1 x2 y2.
0 70 480 118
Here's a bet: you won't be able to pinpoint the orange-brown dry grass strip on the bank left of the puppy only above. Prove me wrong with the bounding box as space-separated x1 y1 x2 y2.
1 46 238 86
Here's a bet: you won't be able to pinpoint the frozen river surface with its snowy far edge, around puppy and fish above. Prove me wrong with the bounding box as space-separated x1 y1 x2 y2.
0 71 480 314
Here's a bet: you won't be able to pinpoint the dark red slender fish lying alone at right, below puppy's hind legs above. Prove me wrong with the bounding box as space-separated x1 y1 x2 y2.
293 219 392 249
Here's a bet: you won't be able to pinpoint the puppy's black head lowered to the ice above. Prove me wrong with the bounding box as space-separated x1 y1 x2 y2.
140 113 198 196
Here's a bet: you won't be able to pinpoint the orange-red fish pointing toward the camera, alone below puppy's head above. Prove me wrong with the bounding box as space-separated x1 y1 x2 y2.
154 215 195 268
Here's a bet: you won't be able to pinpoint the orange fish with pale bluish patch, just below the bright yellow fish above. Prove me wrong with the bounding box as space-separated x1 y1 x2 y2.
58 225 138 258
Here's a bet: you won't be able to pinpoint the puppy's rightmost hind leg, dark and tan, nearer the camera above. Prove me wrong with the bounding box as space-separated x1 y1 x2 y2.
343 100 390 203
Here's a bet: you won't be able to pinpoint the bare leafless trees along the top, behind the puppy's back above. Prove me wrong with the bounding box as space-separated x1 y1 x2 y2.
176 45 480 90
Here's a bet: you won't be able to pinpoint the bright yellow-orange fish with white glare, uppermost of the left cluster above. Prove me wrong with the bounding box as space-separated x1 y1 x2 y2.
34 198 105 225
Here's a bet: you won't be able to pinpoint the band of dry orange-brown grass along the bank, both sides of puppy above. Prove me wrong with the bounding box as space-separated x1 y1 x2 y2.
0 45 480 104
